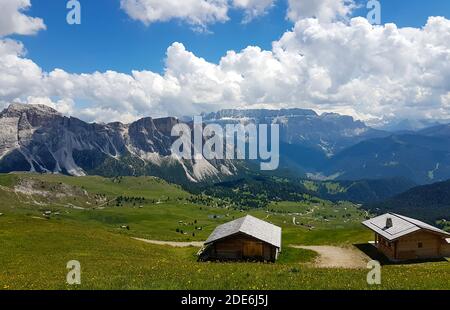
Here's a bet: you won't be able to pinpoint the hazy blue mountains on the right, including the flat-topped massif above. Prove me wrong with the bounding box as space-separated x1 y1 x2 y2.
204 109 450 184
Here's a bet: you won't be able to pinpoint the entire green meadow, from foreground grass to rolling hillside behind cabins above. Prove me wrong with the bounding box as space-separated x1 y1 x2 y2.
0 174 450 290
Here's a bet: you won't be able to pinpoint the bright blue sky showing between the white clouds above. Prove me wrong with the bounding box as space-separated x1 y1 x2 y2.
16 0 450 73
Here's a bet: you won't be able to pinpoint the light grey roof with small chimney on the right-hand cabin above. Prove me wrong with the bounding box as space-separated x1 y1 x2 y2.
363 213 450 240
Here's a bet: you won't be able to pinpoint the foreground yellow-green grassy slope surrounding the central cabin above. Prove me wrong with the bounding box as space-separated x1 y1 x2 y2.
0 212 448 289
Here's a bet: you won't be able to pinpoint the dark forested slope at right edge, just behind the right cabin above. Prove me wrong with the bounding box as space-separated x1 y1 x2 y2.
367 180 450 223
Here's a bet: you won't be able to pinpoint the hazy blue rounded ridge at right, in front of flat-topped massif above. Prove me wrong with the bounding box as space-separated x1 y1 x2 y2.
324 134 450 184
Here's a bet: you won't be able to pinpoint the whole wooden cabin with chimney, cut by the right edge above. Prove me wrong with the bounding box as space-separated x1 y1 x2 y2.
363 213 450 261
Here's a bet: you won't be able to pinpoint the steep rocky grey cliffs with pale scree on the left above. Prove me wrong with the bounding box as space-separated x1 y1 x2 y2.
0 104 236 182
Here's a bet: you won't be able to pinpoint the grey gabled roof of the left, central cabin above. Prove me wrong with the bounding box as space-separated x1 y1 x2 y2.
205 215 281 248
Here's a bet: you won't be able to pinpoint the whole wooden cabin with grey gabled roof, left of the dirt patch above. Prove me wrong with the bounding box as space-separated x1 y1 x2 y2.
199 215 281 262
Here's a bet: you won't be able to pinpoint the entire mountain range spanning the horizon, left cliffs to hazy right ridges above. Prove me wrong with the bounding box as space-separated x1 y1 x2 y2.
0 104 450 185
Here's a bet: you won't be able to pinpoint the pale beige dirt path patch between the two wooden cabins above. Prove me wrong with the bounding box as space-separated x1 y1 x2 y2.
292 245 370 269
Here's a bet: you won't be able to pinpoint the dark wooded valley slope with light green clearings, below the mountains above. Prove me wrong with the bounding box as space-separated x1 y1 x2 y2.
203 176 415 208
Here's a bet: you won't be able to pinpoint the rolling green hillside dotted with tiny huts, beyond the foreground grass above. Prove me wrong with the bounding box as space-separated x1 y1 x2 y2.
0 174 366 243
